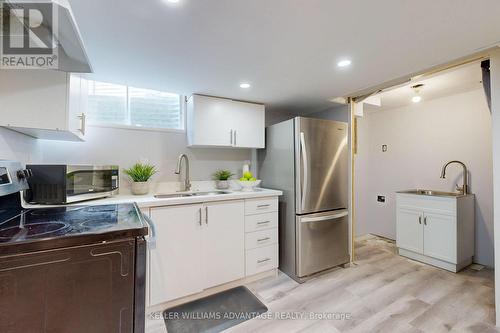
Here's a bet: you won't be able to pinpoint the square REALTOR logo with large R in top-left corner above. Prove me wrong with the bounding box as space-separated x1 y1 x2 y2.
0 0 58 69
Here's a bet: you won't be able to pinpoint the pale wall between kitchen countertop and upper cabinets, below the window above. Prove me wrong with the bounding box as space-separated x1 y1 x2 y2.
0 127 252 187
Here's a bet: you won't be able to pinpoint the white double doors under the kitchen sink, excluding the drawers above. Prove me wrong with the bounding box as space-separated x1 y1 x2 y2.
149 200 245 305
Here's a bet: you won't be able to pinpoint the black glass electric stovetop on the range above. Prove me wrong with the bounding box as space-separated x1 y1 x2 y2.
0 204 147 255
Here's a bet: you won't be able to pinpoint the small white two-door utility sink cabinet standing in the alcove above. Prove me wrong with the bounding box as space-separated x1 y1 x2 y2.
396 193 474 272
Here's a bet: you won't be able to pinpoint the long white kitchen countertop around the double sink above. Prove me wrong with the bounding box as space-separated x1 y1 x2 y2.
23 188 283 208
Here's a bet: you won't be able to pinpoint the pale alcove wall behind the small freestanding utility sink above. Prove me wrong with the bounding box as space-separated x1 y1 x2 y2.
355 90 494 266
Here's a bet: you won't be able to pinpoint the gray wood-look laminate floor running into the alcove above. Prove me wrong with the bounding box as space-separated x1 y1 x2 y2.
147 236 500 333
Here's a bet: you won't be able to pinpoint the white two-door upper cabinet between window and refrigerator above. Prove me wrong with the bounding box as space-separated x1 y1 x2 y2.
187 95 265 148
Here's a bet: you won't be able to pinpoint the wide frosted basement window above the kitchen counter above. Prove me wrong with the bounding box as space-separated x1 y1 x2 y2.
87 80 184 131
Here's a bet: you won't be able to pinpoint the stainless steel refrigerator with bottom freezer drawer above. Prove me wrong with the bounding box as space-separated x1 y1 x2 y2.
258 117 350 282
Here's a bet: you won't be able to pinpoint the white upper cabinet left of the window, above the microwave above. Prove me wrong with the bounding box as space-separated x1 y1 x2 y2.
0 70 87 141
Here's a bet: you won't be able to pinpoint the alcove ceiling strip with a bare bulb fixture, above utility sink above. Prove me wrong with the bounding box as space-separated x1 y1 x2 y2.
364 62 483 112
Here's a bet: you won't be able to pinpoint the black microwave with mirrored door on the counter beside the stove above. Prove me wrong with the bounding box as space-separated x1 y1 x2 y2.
25 164 120 205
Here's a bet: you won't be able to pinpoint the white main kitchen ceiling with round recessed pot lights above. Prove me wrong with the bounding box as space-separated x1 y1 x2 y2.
69 0 500 113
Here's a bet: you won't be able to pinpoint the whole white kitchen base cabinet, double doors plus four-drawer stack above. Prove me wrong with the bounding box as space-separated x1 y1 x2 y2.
147 197 278 306
